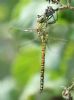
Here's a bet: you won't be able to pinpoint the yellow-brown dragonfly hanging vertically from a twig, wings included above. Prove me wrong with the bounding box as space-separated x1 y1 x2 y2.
10 0 74 93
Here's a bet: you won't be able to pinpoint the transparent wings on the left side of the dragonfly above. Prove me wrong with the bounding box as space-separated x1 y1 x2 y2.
10 27 38 48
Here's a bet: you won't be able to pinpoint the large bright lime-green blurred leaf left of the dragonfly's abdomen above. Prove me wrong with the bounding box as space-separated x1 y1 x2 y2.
12 45 40 87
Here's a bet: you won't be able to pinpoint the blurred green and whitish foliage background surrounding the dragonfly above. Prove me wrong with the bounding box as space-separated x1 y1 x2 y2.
0 0 74 100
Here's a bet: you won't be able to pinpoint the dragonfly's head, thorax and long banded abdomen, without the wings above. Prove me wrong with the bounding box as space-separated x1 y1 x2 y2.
37 6 61 93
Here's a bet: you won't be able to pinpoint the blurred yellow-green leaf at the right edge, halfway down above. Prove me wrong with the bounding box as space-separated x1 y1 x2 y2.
60 41 74 78
